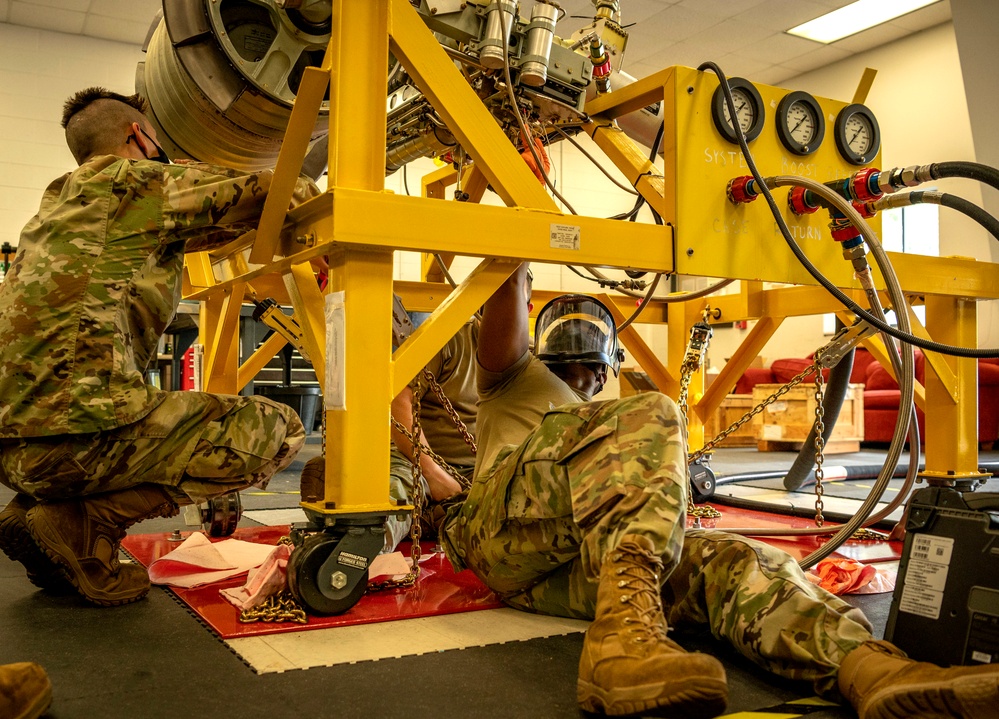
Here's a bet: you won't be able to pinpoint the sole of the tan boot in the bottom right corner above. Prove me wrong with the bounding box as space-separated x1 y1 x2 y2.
861 674 999 719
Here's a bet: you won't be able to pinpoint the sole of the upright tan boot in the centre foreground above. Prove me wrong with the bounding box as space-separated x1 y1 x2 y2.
576 679 728 719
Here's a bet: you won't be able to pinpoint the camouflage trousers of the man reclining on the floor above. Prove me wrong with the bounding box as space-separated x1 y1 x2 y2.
443 393 871 695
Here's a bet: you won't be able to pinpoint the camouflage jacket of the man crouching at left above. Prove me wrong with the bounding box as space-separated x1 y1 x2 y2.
0 155 315 437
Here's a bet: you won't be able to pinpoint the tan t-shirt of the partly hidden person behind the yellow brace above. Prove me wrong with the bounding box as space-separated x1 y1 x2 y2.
410 321 479 469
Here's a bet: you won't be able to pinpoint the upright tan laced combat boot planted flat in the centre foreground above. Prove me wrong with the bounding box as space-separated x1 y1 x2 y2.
576 534 728 717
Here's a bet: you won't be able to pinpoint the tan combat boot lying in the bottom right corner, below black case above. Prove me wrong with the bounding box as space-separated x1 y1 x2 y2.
839 640 999 719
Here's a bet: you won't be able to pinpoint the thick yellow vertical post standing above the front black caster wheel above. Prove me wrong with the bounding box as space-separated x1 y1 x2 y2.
322 0 400 512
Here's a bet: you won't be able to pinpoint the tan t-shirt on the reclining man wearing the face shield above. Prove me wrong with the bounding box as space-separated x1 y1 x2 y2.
475 352 590 475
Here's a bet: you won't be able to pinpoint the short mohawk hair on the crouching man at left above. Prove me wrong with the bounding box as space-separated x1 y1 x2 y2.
62 87 149 165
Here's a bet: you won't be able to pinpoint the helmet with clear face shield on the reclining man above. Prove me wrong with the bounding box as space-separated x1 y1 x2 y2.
534 295 624 377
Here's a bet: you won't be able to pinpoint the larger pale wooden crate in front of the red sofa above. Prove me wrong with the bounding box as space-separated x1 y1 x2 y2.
753 382 864 454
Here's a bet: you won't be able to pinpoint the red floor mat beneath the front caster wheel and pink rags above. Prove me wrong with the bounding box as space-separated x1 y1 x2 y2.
121 526 504 639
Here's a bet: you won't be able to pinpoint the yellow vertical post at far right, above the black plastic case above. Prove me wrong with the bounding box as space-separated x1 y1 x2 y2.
924 295 980 480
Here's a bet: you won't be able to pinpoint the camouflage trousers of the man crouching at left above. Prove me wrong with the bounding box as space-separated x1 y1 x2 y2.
0 392 305 504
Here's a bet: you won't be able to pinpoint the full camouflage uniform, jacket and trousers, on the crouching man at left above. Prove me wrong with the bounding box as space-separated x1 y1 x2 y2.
0 155 318 500
